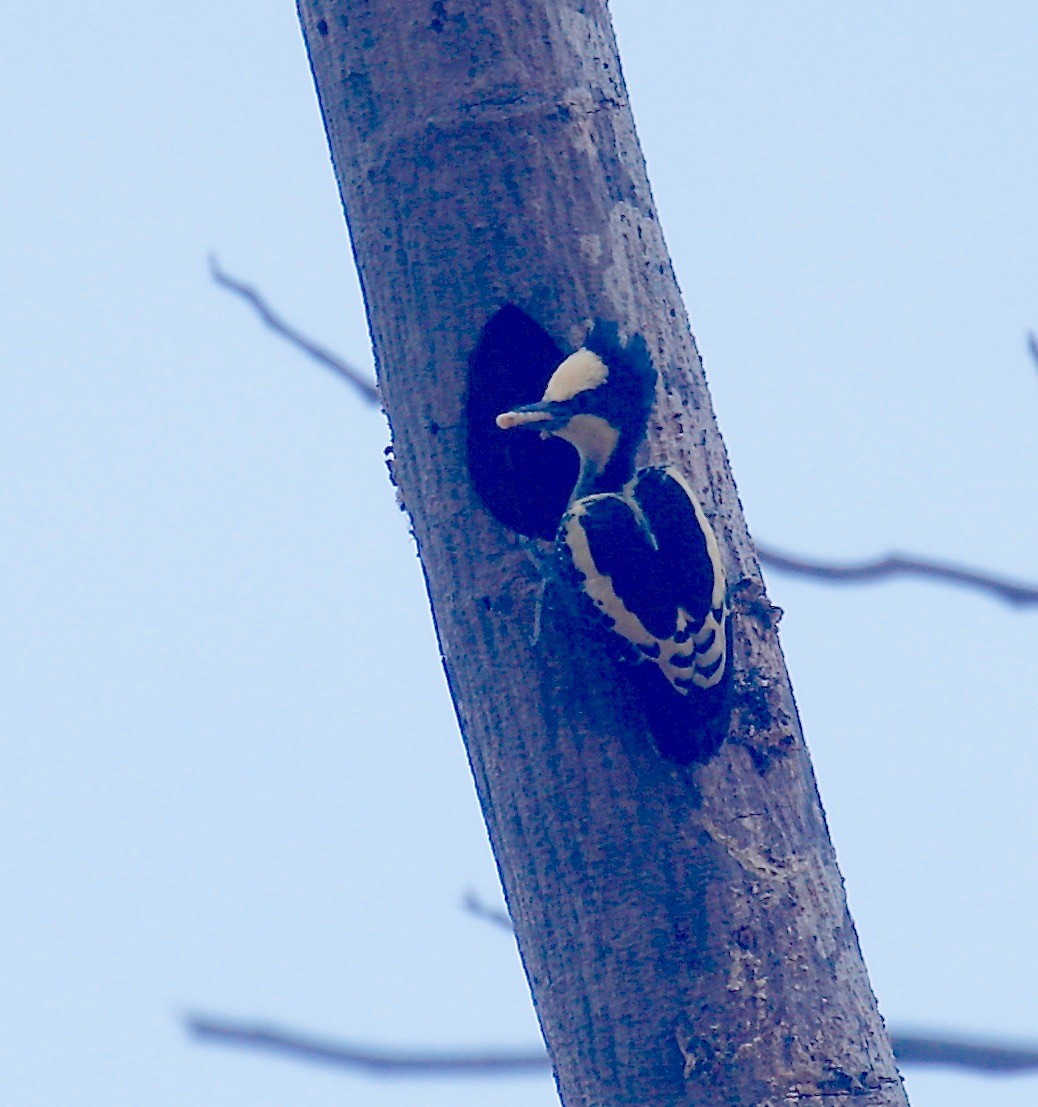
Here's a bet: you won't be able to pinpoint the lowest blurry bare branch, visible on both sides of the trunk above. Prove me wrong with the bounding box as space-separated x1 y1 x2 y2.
186 1015 1038 1077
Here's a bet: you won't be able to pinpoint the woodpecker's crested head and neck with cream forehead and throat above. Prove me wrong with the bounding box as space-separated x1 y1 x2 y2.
497 323 656 494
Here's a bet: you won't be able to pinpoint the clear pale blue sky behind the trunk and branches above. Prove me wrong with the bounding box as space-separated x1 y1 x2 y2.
0 0 1038 1107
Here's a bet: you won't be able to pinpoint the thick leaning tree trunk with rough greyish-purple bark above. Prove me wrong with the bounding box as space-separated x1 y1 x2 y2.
299 0 906 1107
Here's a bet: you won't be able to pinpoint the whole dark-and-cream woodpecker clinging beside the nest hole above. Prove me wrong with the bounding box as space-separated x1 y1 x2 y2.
497 322 731 761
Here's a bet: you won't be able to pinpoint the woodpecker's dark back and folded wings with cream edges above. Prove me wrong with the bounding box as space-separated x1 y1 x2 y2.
560 468 730 693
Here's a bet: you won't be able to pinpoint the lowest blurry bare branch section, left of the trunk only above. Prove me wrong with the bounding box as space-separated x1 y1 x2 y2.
185 1015 550 1076
